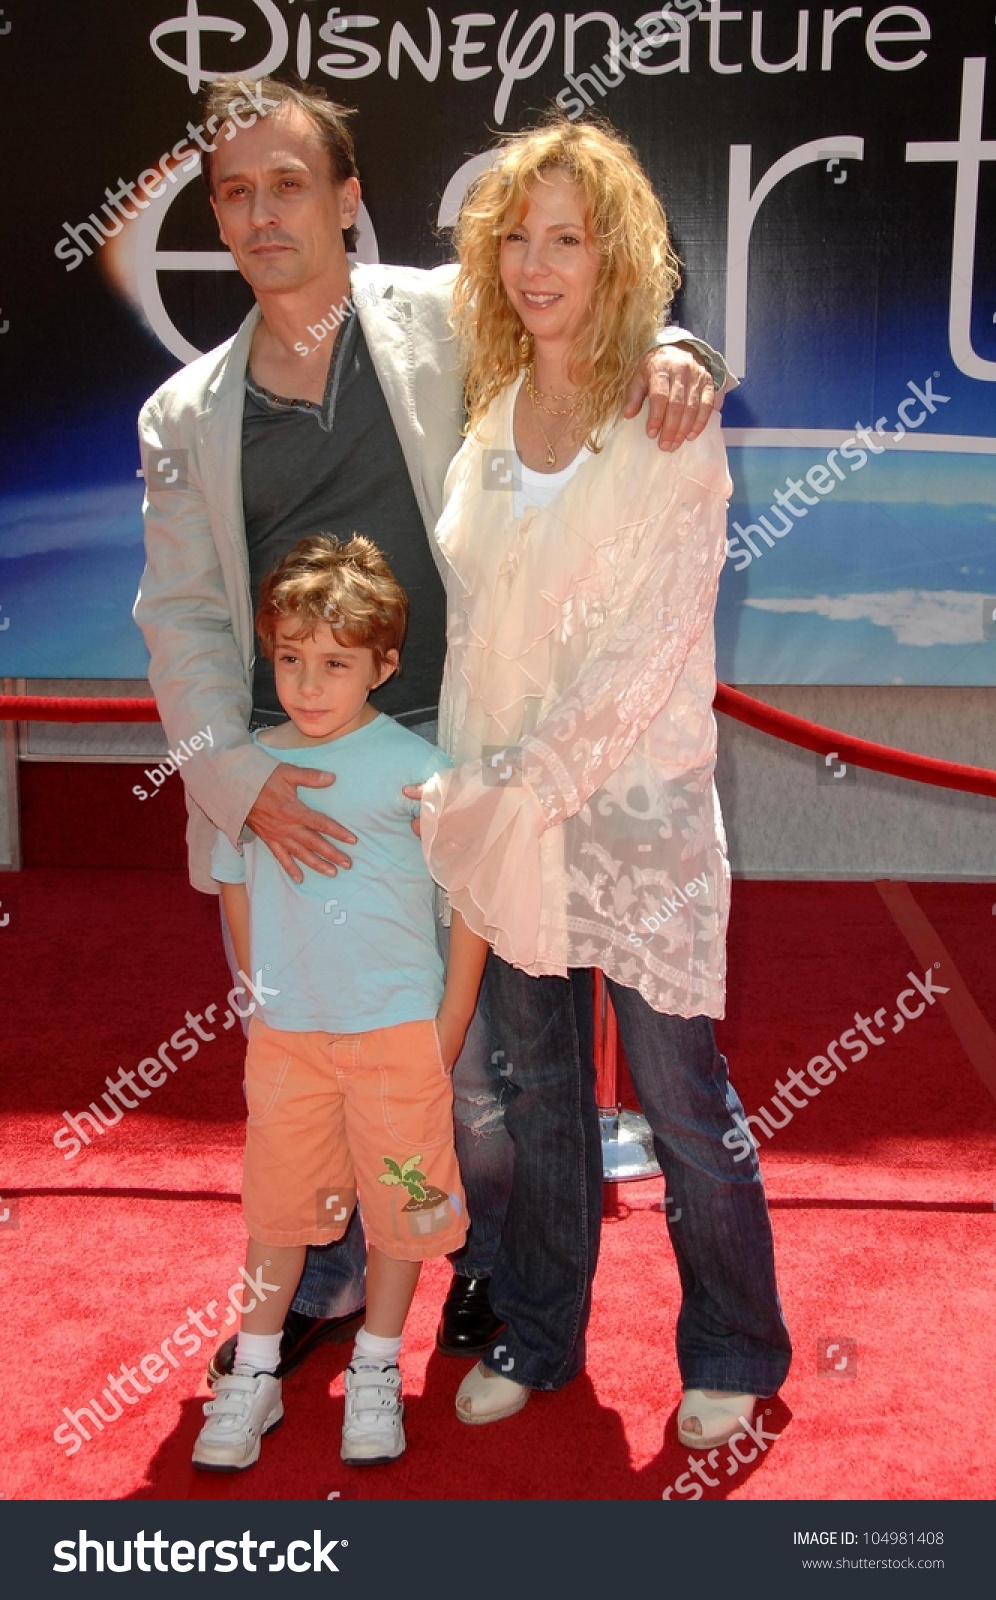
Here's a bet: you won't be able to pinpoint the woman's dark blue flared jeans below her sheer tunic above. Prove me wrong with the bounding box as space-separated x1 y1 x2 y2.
484 955 791 1395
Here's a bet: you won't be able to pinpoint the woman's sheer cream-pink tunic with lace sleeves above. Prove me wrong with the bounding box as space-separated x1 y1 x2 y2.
421 381 732 1018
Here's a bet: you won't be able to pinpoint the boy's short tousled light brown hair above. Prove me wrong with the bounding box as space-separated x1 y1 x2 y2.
256 533 408 669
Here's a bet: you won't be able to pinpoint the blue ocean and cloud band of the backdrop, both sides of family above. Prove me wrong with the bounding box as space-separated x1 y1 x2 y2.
0 448 996 685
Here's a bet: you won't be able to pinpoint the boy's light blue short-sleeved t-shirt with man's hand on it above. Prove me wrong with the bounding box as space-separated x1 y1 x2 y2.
211 715 453 1034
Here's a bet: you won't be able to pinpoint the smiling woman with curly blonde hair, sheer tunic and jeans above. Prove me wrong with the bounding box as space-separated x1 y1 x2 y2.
423 118 789 1448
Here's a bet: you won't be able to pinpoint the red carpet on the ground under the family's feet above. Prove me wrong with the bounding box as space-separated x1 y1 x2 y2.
0 838 996 1499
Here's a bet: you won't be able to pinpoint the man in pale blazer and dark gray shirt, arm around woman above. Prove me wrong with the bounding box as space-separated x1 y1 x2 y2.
135 78 729 1376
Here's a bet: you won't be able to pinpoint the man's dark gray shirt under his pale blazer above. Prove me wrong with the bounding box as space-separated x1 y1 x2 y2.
242 312 448 725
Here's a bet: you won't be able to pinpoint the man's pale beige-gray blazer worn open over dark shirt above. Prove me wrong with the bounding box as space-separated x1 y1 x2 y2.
135 264 725 894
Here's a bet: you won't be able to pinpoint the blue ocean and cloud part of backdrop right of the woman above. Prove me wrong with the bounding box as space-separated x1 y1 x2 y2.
716 448 996 685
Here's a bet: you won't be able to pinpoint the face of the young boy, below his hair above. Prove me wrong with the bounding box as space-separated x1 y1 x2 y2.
274 621 397 744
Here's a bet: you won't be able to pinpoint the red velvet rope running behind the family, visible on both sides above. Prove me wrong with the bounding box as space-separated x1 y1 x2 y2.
0 683 996 797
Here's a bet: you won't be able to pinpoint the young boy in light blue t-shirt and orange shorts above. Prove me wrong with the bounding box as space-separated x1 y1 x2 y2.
194 536 487 1472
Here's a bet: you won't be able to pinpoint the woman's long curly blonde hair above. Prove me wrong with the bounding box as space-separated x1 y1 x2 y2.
450 114 681 450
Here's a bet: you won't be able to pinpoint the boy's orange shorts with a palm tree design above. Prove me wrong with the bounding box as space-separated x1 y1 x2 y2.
242 1016 468 1261
